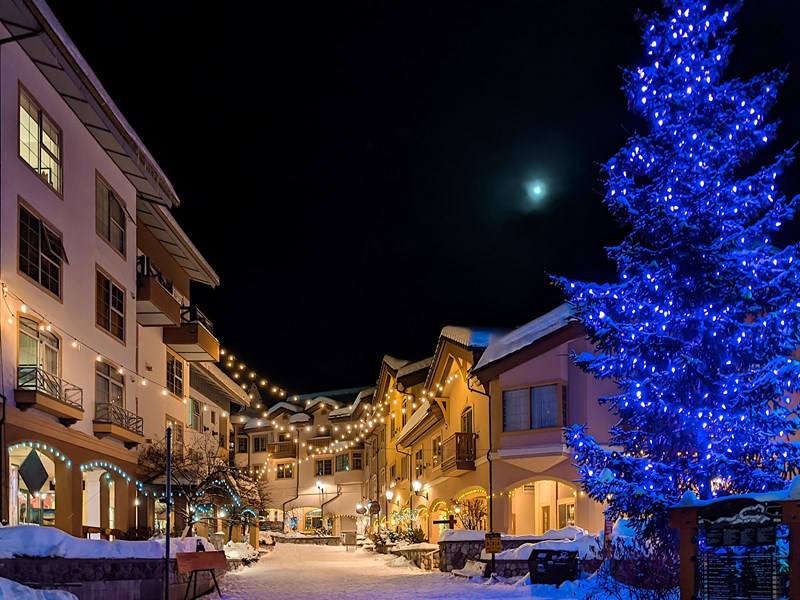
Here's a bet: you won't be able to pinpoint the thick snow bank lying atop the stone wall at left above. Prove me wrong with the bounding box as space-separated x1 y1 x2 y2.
0 525 214 558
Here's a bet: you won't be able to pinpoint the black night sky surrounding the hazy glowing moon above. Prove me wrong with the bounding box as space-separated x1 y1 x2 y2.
45 0 800 393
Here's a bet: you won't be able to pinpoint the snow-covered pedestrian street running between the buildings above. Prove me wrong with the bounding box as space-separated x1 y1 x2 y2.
221 544 586 600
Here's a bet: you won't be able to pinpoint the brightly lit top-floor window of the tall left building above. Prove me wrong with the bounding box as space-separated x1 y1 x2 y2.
19 88 62 195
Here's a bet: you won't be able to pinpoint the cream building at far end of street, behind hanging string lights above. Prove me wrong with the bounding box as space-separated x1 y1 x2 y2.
232 388 372 534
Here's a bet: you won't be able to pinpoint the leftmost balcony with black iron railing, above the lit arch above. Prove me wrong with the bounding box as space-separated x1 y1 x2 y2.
14 367 83 427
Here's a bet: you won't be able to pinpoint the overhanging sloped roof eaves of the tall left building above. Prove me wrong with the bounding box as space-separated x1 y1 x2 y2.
0 0 219 286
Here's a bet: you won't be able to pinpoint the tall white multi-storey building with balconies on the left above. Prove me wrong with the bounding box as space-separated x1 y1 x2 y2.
0 0 219 536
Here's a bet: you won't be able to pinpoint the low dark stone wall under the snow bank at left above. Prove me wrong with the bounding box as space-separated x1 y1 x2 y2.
0 558 223 600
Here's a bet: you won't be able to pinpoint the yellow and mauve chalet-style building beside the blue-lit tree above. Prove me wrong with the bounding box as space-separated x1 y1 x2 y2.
363 305 615 542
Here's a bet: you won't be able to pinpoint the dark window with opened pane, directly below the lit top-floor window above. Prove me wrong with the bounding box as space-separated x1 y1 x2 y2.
19 205 69 298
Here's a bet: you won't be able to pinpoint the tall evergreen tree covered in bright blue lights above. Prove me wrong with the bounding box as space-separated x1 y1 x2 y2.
554 0 800 533
